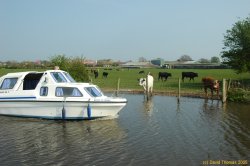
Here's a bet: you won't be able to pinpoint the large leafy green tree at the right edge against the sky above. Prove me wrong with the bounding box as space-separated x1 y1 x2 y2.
222 17 250 73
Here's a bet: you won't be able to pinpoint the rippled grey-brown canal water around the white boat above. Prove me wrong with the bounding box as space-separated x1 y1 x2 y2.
0 94 250 166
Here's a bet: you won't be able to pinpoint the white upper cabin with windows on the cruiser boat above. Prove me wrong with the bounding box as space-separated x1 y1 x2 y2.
0 70 103 98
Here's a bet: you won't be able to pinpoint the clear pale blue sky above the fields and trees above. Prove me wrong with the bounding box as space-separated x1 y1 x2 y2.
0 0 250 61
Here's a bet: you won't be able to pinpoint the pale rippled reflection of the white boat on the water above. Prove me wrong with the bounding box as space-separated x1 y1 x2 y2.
0 117 126 165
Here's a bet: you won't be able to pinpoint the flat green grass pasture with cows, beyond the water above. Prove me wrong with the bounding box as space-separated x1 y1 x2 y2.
0 68 250 93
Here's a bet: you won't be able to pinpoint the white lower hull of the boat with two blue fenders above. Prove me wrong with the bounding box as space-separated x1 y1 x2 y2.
0 101 126 120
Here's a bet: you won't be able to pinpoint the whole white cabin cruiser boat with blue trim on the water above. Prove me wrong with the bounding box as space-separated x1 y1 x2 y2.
0 70 127 119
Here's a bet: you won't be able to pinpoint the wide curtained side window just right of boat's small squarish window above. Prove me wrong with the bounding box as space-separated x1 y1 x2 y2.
55 87 83 97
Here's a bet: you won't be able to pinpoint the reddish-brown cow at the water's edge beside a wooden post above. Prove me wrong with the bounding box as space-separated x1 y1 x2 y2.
202 77 220 97
